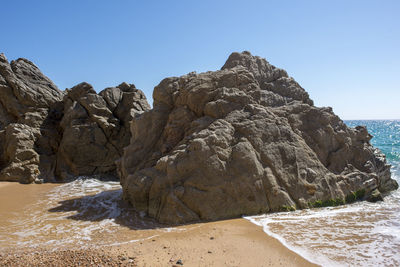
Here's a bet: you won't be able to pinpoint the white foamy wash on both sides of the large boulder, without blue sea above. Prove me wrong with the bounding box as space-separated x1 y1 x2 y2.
4 174 400 266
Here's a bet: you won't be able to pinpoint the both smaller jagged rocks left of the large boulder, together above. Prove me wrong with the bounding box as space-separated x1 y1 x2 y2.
0 54 150 183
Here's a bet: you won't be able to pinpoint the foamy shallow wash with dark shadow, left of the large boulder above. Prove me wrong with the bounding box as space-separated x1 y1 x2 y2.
0 177 169 248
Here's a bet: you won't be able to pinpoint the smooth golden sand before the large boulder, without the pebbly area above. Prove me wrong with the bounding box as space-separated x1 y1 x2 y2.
111 219 315 266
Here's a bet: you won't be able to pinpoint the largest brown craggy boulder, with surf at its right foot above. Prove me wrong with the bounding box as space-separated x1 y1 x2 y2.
118 52 397 223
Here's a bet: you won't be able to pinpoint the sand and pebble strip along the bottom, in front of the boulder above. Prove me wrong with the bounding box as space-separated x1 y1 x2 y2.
0 218 319 267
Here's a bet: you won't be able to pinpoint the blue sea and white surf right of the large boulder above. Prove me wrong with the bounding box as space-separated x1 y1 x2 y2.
246 120 400 266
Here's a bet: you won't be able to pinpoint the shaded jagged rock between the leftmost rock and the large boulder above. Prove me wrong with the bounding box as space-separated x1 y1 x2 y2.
56 83 150 180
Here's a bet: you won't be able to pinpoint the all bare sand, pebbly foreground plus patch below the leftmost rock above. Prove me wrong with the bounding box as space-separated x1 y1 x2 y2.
0 183 314 266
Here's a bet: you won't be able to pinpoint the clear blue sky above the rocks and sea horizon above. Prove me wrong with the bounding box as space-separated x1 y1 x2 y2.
0 0 400 119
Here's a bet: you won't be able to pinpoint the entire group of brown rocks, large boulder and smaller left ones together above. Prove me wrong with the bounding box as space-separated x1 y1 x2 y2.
0 52 398 223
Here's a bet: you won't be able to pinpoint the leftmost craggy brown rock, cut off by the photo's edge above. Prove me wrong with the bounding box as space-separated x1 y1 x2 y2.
0 54 63 183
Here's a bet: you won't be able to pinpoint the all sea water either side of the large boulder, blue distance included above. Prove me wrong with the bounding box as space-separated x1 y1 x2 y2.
0 120 400 266
